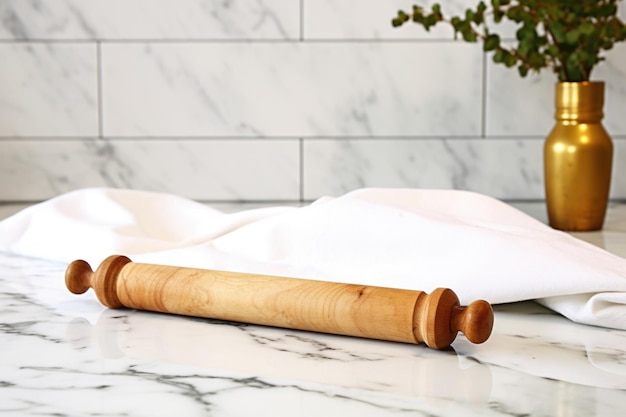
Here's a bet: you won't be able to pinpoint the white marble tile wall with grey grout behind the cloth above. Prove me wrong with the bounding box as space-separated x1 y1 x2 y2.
0 0 626 202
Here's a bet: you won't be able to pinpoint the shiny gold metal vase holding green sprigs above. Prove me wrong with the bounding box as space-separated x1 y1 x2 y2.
544 81 613 231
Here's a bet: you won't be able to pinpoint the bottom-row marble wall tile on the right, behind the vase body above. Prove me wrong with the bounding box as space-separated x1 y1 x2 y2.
303 137 626 200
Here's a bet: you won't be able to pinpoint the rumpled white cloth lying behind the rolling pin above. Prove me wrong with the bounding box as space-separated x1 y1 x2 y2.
0 189 626 329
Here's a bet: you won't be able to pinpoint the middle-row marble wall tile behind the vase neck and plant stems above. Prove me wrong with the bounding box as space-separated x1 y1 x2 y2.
486 44 626 137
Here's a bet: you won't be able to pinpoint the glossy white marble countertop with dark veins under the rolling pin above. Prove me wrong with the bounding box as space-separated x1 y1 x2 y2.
0 201 626 417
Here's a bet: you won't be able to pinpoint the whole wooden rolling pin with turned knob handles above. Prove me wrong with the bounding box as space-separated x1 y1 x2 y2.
65 255 493 349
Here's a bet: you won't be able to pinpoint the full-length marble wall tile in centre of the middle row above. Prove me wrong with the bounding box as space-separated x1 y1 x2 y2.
102 42 482 137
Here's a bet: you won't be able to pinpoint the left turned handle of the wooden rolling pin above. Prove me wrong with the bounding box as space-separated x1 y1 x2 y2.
65 255 130 308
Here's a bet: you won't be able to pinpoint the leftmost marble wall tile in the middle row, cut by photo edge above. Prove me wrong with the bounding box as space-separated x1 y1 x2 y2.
0 42 98 137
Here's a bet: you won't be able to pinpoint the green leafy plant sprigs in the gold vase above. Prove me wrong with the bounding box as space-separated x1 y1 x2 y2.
392 0 626 81
